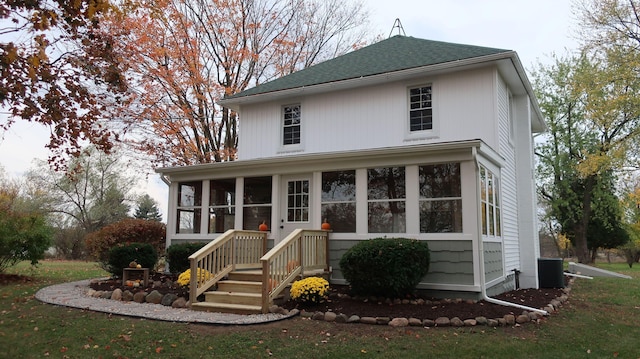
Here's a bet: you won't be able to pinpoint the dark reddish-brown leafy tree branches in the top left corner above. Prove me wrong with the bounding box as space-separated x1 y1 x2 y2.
0 0 127 168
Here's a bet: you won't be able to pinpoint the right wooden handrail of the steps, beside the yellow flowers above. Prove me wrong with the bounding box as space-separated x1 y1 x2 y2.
260 229 329 313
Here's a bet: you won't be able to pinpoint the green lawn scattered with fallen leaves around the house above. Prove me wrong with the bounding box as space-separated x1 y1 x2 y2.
0 261 640 358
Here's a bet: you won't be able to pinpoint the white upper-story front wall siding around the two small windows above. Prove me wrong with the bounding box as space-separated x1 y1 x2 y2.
238 68 497 160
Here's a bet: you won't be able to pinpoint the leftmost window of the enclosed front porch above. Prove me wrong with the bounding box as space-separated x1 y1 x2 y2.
176 181 202 233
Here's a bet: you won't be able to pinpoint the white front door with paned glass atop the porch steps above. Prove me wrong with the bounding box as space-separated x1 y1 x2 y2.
280 174 312 239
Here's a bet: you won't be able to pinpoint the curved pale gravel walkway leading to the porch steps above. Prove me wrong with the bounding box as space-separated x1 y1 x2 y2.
36 280 293 325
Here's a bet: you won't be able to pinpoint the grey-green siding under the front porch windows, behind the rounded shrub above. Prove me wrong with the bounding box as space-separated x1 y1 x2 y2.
329 240 474 285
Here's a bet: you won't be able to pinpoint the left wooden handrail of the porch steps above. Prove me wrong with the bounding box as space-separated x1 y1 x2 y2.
189 229 267 303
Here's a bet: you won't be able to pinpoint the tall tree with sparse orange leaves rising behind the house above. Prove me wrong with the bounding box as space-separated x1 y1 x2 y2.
106 0 367 166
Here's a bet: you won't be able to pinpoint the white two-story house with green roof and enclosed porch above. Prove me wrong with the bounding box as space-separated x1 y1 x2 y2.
158 36 545 298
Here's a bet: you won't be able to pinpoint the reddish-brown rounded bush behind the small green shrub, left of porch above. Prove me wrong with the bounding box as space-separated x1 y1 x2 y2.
86 218 166 270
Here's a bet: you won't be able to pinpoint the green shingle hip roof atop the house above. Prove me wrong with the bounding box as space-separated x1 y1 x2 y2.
225 35 510 99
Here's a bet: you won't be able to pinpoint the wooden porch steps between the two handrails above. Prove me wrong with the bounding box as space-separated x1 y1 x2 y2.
191 270 262 314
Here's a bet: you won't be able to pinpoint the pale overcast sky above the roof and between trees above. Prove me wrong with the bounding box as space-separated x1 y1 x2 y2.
0 0 577 220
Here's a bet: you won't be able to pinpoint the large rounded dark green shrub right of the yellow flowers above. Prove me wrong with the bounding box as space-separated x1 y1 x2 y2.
340 238 429 297
